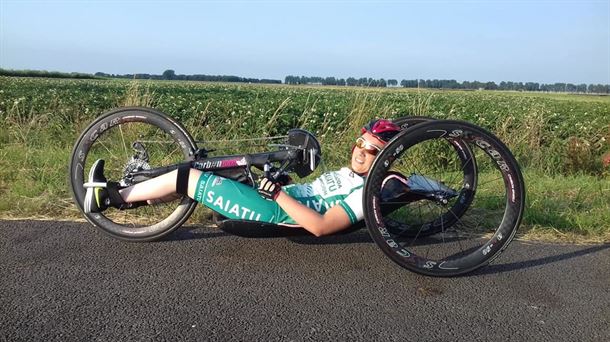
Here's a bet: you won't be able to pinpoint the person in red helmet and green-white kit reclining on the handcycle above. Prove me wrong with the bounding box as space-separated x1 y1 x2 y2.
83 119 400 236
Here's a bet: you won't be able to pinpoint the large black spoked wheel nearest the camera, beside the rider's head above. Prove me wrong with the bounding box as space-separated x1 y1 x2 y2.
363 121 525 276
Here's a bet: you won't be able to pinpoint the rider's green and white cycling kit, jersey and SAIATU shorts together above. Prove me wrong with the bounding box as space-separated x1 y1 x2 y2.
195 168 364 224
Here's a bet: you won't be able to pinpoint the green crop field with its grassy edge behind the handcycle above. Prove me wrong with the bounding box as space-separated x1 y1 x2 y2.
0 77 610 241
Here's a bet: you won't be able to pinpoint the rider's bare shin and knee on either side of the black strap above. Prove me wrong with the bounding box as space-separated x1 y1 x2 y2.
119 169 202 203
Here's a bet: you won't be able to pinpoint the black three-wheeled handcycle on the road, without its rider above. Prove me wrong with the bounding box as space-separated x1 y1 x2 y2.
70 107 525 276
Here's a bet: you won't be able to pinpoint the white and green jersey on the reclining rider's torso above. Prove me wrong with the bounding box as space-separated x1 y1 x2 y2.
282 167 364 224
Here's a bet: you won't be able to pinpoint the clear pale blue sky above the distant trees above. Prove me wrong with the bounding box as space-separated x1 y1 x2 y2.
0 0 610 84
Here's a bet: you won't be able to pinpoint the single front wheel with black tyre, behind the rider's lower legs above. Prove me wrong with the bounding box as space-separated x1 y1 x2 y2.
69 107 197 242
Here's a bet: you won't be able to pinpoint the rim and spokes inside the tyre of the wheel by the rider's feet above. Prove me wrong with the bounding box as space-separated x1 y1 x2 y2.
71 111 192 238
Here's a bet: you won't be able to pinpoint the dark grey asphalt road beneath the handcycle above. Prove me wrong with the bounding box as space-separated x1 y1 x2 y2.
0 221 610 341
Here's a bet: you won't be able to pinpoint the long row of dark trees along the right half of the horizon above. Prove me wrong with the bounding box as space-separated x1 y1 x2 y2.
284 75 610 94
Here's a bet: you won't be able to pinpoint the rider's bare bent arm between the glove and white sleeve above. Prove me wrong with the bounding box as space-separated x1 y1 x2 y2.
276 191 351 237
